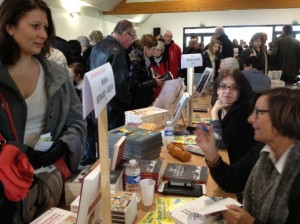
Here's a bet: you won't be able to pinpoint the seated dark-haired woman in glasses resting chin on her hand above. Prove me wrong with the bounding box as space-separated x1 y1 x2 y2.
210 69 256 163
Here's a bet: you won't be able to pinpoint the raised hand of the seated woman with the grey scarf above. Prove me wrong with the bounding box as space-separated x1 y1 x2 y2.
196 124 218 162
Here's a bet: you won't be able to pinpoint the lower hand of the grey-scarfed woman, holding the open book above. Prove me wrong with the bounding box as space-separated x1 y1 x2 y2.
222 205 255 224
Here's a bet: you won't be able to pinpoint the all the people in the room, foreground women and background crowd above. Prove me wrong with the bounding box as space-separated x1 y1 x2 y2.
0 0 300 224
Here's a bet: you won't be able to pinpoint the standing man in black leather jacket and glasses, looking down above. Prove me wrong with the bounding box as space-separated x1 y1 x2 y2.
90 20 136 130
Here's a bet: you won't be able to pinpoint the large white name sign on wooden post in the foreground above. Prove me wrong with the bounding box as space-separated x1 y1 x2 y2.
82 63 116 223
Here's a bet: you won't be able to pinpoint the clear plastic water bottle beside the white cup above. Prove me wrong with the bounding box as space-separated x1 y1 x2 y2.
125 159 141 202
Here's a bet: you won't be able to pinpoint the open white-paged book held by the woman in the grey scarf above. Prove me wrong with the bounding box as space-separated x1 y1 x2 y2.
168 196 242 224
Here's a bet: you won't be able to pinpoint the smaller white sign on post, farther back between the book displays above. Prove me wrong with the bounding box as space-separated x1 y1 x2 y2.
181 54 203 126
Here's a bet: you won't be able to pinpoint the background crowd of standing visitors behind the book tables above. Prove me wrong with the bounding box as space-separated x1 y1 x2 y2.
49 20 300 169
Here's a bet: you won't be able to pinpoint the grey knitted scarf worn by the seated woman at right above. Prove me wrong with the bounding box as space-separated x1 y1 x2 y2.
244 141 300 224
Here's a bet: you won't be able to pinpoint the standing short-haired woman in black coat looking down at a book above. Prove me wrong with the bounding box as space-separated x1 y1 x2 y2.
129 34 165 110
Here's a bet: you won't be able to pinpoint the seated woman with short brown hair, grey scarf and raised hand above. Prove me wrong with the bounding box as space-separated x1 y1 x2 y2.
196 87 300 224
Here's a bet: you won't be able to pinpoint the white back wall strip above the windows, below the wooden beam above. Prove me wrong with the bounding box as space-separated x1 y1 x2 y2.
138 9 300 47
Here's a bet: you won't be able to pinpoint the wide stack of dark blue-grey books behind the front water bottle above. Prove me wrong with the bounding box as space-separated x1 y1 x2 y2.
108 125 162 159
